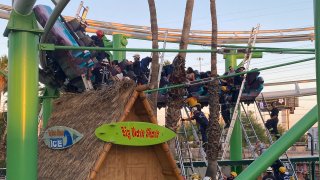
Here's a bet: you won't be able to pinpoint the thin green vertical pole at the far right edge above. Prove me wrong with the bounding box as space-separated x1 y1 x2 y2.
313 0 320 162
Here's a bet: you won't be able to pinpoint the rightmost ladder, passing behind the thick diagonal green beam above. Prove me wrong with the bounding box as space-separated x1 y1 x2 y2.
255 96 298 180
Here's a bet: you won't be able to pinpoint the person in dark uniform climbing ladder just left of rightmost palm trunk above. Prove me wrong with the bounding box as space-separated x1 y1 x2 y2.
191 106 209 144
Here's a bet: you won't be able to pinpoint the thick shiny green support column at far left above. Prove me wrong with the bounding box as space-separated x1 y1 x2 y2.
4 8 40 180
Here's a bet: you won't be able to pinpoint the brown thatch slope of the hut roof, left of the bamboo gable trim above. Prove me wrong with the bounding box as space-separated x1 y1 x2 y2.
38 81 135 180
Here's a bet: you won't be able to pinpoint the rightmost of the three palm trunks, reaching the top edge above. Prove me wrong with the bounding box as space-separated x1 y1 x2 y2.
206 0 221 179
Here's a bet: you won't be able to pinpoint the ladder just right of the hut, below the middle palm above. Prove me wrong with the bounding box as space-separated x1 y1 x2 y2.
176 113 195 179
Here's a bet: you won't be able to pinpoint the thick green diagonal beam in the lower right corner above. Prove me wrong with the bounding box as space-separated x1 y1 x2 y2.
236 106 318 180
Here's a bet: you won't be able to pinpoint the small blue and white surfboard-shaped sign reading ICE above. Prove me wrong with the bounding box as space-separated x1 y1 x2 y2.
43 126 83 149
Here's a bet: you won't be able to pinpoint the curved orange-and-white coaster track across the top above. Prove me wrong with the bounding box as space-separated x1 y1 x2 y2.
0 4 314 46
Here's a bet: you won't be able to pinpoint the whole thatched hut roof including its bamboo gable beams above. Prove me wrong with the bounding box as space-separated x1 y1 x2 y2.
38 81 182 180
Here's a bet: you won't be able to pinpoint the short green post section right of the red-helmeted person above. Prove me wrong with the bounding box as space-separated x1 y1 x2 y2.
112 34 128 62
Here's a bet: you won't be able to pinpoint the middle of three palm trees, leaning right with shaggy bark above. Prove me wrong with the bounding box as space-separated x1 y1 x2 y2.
166 0 194 131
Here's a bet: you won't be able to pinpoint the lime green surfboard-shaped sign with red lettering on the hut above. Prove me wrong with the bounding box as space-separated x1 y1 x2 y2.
95 122 176 146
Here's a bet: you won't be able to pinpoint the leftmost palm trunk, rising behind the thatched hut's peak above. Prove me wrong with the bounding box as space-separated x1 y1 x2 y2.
148 0 159 116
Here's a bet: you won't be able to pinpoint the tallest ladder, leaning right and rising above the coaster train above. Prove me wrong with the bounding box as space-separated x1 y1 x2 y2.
220 24 260 160
